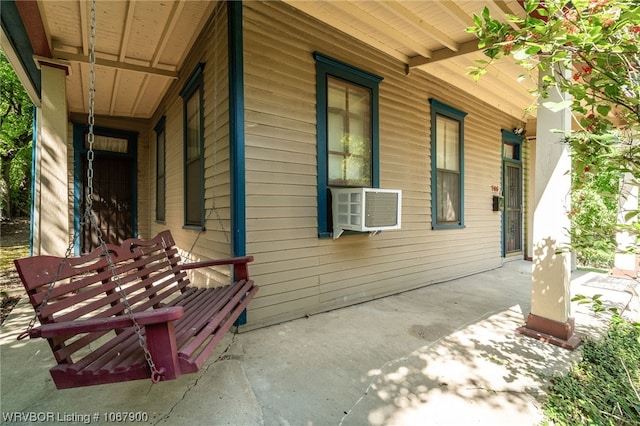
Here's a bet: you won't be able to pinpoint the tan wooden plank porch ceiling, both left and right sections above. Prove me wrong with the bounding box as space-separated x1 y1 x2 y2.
32 0 535 118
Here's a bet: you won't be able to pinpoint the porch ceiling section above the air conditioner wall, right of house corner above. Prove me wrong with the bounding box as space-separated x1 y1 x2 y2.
284 0 537 120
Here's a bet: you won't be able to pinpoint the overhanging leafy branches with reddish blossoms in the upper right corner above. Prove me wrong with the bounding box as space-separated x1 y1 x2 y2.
468 0 640 133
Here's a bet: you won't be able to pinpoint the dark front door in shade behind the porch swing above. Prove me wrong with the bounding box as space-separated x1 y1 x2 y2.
76 125 137 253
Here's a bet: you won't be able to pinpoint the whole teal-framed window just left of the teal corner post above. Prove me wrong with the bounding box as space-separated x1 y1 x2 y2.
180 63 204 228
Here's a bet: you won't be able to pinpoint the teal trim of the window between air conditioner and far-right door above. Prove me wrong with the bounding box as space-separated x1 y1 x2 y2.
429 98 467 230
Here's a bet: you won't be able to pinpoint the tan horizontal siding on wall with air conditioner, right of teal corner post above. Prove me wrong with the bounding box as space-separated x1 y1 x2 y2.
243 2 520 327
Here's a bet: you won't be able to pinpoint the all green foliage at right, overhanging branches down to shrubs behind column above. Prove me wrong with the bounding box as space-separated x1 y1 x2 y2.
467 0 640 266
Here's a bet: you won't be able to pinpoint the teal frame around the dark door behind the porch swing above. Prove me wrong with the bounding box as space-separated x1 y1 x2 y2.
73 123 138 256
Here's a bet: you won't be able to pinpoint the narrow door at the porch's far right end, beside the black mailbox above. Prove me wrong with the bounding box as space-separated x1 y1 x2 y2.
504 161 522 254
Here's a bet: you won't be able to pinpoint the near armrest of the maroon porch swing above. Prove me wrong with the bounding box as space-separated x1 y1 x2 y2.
29 306 184 338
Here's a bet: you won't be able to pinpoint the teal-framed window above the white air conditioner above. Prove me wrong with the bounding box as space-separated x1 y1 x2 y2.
313 52 382 237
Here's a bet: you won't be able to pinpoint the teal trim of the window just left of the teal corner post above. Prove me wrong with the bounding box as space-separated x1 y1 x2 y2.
180 62 205 230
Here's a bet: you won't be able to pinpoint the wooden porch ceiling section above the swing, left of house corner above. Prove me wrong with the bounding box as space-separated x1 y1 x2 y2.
16 0 216 118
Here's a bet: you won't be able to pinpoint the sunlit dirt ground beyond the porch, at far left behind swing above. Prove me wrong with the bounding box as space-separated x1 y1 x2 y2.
0 218 29 323
